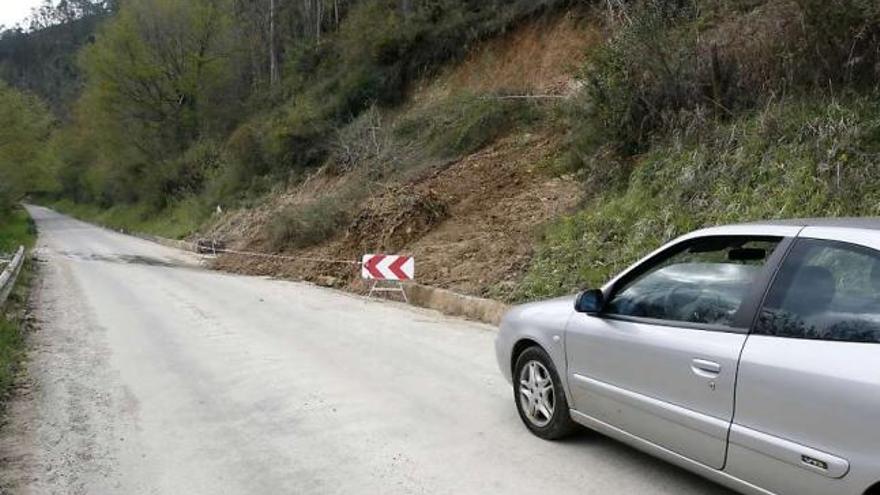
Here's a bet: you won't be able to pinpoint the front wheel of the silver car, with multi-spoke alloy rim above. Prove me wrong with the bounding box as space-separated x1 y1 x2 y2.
513 347 577 440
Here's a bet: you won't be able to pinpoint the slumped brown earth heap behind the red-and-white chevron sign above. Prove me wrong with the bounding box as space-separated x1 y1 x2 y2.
217 131 583 299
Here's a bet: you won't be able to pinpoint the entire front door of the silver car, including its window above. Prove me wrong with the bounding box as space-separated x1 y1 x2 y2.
566 236 788 469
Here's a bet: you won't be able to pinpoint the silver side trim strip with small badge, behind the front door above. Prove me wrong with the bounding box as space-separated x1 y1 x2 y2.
730 423 849 479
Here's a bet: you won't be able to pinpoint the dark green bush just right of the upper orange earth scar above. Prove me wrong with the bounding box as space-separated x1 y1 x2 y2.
572 0 720 160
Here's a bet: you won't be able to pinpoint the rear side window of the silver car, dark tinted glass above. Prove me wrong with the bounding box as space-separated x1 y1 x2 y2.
754 239 880 343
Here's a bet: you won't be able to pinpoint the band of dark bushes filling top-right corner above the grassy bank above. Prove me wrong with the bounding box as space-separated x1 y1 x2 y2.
571 0 880 166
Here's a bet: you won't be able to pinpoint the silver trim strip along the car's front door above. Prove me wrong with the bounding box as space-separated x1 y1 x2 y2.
572 373 730 442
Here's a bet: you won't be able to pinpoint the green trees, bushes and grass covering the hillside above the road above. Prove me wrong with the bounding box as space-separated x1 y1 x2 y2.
0 0 880 301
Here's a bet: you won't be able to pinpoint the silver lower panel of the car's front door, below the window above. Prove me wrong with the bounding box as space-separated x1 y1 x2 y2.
566 314 746 468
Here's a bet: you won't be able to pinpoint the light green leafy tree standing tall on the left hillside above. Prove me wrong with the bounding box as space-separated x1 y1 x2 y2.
76 0 246 207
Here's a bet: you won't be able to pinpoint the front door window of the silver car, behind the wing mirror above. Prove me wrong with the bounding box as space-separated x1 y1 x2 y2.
605 237 781 326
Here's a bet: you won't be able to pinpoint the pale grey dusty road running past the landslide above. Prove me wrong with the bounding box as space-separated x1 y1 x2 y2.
0 208 729 495
